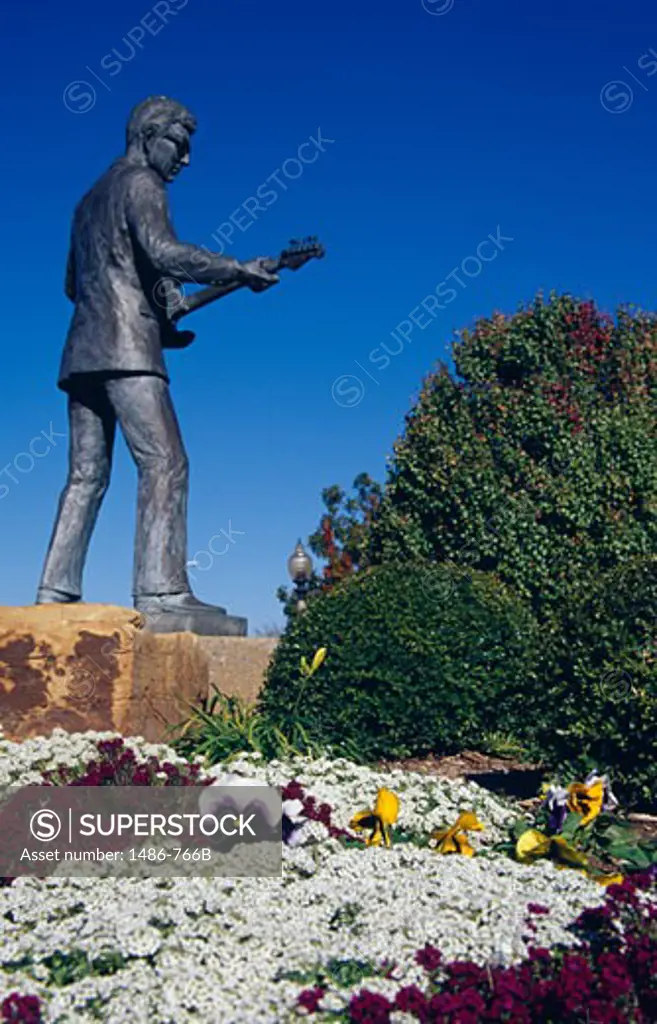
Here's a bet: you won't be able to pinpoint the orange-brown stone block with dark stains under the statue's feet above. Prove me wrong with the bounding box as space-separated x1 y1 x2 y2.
0 604 209 741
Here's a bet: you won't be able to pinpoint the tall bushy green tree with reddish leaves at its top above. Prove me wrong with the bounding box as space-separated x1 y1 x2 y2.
367 295 657 622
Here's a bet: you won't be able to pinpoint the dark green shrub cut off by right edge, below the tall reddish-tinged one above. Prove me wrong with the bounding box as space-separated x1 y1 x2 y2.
536 558 657 807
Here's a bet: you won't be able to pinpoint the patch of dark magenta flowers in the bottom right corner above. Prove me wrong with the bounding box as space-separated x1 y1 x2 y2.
298 871 657 1024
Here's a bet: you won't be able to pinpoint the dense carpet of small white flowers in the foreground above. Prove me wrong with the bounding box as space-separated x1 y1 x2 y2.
0 732 640 1024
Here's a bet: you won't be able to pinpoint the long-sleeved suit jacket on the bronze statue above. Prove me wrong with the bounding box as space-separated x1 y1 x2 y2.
58 157 236 390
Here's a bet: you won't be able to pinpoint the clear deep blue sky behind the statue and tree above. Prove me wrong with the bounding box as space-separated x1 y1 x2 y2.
0 0 657 630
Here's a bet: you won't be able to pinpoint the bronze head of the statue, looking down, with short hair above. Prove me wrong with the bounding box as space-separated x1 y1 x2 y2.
126 96 196 181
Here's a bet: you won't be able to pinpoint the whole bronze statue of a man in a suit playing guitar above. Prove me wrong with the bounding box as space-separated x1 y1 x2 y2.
37 96 322 635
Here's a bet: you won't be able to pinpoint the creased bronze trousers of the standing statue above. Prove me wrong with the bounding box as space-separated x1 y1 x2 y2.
40 374 189 597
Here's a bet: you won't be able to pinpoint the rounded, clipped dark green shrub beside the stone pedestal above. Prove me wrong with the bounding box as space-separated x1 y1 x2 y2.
261 564 539 760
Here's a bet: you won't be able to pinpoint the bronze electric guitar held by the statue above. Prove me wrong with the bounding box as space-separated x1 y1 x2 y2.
162 236 325 348
